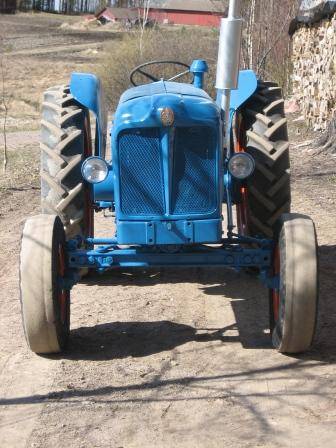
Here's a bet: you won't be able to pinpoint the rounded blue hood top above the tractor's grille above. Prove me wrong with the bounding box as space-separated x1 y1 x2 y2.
113 81 220 136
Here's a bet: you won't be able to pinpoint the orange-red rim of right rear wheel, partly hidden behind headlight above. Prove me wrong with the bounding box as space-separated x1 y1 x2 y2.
234 117 249 236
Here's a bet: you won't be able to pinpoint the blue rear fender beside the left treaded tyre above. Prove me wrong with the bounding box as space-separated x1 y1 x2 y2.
70 73 107 158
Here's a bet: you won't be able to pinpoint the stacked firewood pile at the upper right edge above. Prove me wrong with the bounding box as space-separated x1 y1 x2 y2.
292 14 336 130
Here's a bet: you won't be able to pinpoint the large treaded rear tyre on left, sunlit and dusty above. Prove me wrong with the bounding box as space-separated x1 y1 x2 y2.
40 86 91 239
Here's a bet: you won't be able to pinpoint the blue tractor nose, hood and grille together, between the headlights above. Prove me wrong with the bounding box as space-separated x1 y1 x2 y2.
111 81 223 245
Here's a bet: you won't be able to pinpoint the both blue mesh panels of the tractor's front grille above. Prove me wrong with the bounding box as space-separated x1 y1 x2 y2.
119 126 217 216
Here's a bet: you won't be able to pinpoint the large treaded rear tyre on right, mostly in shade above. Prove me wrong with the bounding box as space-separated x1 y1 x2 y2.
241 81 291 238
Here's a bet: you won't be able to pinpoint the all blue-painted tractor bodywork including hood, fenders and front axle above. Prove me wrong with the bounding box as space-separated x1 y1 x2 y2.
68 61 276 290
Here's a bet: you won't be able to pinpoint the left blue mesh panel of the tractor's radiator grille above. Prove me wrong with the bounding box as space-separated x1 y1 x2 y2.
119 128 164 215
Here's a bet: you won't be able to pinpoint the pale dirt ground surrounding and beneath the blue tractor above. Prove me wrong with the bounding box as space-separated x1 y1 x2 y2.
0 12 336 448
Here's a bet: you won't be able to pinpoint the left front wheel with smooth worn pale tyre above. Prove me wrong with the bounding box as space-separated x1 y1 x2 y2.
20 215 70 354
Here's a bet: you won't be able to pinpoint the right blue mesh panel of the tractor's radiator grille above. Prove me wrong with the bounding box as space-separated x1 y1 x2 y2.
171 126 216 215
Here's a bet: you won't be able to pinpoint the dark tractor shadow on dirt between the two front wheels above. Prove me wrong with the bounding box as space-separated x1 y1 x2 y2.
67 268 271 360
